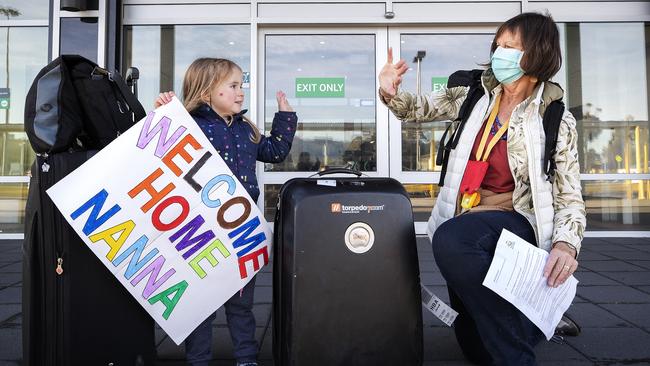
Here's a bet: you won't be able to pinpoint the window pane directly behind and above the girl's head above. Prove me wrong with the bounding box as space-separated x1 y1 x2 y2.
124 25 250 108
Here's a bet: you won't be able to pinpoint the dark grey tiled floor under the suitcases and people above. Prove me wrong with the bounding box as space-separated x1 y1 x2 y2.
0 237 650 366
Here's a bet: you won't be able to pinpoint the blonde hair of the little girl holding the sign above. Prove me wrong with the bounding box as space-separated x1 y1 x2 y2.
183 57 262 144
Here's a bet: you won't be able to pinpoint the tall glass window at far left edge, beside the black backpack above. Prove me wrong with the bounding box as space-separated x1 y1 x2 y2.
0 8 49 239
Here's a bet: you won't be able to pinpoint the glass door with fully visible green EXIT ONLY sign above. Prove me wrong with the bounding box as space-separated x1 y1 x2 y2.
257 28 389 221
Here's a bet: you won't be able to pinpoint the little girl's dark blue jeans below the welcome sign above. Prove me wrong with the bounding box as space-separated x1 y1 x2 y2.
185 277 258 366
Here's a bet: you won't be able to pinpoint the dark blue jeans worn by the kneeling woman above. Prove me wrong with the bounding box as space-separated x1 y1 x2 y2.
432 211 544 366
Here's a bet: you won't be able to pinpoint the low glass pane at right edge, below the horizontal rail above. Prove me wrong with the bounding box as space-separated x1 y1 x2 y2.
582 180 650 231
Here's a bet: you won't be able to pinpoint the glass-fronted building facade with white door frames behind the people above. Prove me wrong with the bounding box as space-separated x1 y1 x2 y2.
0 0 650 238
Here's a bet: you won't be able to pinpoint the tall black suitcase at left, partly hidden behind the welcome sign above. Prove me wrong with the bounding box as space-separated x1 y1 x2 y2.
22 151 155 366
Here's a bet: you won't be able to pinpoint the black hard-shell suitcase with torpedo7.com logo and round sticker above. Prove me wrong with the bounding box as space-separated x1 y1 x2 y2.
273 171 422 366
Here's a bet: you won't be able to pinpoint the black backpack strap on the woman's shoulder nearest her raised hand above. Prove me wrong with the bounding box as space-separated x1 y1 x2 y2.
436 70 485 187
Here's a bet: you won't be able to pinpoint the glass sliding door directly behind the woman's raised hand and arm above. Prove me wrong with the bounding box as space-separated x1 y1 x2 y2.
389 31 493 227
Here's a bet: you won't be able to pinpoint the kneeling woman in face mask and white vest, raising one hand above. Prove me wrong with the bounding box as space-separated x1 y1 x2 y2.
379 13 586 366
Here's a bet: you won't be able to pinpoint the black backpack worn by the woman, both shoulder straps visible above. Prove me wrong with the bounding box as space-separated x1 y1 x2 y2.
436 70 564 187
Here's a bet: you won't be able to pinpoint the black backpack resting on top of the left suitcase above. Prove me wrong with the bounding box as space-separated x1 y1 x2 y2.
25 55 146 154
